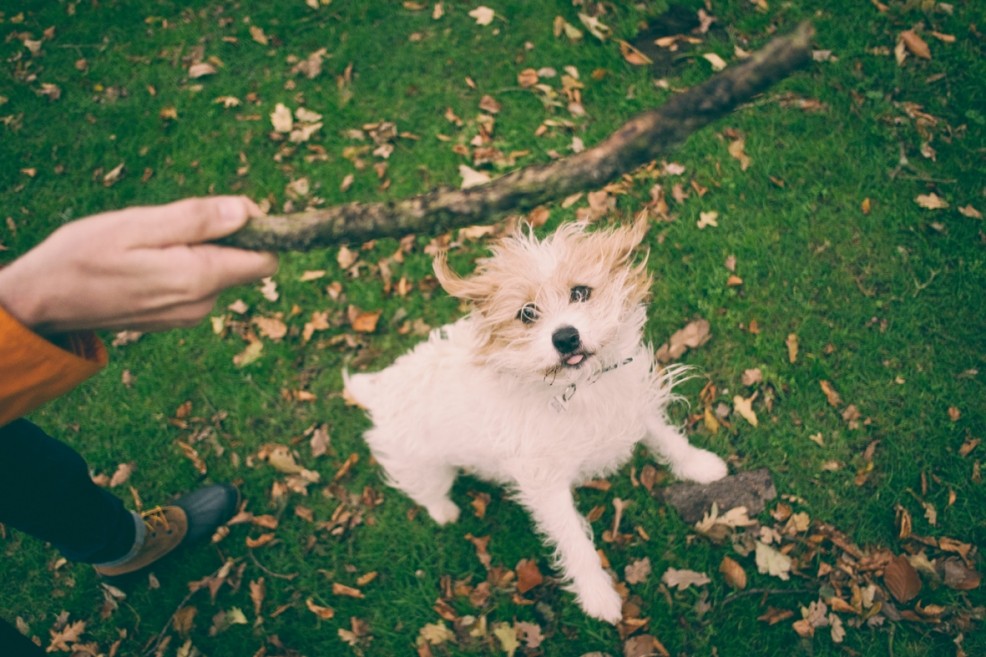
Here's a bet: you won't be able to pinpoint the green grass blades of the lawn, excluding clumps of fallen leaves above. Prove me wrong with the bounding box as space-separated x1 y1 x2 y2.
0 0 986 656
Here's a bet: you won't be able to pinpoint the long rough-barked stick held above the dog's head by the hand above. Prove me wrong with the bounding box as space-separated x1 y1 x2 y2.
220 23 814 251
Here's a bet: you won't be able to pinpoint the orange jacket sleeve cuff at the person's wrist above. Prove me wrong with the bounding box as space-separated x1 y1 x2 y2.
0 308 107 426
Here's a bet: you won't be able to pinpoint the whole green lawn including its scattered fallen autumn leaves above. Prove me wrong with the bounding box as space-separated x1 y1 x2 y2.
0 0 986 657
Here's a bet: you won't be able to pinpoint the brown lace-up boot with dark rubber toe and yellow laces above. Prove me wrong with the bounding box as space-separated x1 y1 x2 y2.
94 484 240 577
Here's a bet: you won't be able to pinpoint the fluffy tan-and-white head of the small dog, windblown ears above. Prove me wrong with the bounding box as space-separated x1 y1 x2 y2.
434 219 651 381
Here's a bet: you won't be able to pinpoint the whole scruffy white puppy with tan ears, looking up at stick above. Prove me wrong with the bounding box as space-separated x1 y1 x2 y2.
344 221 727 623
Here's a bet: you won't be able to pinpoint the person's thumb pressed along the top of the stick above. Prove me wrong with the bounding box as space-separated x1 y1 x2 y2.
129 196 262 248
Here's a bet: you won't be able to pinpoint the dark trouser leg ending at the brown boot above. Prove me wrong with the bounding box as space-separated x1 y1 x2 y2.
0 420 135 563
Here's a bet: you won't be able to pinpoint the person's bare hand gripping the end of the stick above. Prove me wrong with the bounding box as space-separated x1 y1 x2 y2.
0 196 277 335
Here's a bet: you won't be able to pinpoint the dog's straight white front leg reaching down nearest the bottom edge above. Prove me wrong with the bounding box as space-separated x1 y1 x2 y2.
517 482 623 624
